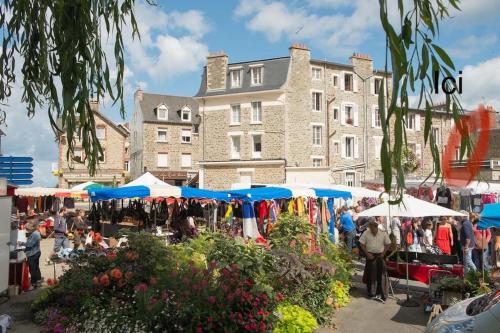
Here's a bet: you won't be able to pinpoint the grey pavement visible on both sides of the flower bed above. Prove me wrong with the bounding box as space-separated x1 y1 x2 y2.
0 239 428 333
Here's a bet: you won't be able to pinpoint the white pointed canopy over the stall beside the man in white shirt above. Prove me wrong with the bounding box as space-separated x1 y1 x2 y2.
359 195 466 217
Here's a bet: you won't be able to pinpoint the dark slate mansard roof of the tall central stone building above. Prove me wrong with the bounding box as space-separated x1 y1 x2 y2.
195 57 290 97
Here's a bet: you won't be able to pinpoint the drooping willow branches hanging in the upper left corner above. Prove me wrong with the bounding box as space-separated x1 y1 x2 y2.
0 0 152 175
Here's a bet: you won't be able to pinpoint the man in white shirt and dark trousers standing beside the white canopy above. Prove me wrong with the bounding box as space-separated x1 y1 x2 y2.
359 218 391 302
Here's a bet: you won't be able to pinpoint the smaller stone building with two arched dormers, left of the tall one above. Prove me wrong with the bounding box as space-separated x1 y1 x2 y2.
130 90 200 185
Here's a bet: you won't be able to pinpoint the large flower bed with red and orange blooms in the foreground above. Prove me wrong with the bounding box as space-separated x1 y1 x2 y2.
32 216 351 332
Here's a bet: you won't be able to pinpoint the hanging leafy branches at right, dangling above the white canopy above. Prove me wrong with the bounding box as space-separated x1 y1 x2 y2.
379 0 472 202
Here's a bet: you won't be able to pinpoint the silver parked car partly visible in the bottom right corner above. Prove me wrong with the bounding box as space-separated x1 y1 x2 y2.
425 289 500 333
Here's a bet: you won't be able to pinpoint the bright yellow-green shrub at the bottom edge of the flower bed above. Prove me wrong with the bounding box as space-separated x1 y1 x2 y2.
273 305 318 333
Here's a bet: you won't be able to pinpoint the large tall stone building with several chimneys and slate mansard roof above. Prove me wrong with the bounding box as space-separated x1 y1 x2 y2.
195 44 472 189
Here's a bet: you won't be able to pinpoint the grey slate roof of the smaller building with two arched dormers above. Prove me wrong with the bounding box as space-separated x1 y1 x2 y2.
139 92 200 124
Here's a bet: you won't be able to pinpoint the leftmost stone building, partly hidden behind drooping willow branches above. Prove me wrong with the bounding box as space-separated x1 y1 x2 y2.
56 103 130 188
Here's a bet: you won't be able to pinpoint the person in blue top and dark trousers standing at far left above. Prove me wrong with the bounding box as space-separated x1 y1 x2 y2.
18 216 43 290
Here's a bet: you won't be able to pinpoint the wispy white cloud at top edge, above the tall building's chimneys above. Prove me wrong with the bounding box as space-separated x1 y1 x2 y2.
235 0 379 55
